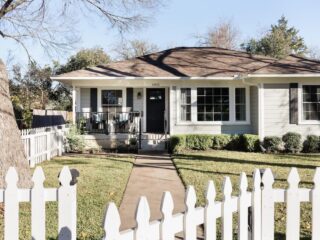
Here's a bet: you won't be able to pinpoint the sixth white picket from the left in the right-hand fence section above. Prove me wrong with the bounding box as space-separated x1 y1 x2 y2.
221 177 233 240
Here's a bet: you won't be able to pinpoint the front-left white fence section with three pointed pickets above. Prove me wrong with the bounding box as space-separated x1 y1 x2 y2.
0 167 77 240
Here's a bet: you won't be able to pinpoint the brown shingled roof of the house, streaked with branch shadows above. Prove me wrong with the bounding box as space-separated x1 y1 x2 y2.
57 47 320 79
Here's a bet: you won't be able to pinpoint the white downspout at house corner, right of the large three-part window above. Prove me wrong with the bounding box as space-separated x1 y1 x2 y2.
236 75 265 142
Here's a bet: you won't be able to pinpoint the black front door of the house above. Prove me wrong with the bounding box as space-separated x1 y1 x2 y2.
147 88 165 133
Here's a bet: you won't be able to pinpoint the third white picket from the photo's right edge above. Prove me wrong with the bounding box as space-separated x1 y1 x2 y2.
261 168 274 240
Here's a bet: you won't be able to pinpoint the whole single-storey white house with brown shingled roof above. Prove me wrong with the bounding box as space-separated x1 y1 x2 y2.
52 47 320 150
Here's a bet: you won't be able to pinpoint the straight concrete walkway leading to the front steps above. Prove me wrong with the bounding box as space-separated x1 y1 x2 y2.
120 153 185 230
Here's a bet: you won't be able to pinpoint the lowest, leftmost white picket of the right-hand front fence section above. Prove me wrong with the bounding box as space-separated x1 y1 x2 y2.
103 203 121 240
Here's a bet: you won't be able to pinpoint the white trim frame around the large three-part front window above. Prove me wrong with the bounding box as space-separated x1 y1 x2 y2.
175 85 251 126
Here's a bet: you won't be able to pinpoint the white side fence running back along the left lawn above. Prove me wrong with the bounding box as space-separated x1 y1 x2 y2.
21 125 69 167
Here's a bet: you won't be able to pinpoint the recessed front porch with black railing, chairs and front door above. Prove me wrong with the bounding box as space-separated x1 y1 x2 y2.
73 87 169 150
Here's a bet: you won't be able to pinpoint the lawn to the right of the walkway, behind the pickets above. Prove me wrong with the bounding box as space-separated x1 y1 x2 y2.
174 151 320 239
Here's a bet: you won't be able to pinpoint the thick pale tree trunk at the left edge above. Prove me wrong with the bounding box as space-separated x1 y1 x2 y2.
0 59 31 188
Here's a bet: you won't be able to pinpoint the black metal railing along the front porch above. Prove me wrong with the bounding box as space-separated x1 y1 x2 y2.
76 112 141 134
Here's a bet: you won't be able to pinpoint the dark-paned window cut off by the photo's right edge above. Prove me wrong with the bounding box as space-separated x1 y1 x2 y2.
302 85 320 121
